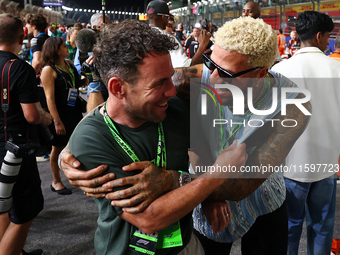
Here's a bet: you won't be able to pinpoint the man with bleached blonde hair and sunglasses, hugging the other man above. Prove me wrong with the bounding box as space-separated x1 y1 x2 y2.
62 17 310 255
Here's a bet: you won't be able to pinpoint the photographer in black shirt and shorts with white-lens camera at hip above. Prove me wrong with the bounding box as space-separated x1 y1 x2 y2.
0 14 52 255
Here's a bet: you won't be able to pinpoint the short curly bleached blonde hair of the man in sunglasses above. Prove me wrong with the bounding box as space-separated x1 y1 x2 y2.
215 17 278 68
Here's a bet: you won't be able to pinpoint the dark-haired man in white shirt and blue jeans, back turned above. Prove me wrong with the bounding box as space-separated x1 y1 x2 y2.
272 11 340 255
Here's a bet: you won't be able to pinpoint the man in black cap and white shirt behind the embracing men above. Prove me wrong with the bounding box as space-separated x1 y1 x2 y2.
146 0 210 68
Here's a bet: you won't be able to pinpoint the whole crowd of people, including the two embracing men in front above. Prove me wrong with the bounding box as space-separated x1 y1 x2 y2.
0 0 340 255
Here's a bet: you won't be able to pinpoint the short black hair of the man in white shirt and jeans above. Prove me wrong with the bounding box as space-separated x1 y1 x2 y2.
296 11 334 41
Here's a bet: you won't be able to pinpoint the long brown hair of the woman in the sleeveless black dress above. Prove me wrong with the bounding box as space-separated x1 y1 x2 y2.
40 37 64 66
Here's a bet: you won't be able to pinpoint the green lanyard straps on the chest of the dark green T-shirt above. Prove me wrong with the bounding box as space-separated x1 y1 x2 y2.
104 101 166 169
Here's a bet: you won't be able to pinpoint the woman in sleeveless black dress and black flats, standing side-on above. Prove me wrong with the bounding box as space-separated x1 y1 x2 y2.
41 38 87 195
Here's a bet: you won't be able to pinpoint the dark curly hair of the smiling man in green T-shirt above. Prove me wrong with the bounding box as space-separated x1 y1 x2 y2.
93 20 178 85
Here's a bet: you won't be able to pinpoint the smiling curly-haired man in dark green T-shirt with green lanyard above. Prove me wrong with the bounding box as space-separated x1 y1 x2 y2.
70 20 246 255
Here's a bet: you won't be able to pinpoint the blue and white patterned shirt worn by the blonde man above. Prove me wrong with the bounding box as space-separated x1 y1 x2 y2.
193 66 297 243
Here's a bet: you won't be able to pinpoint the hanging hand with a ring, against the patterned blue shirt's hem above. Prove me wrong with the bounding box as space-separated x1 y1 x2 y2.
202 201 231 233
